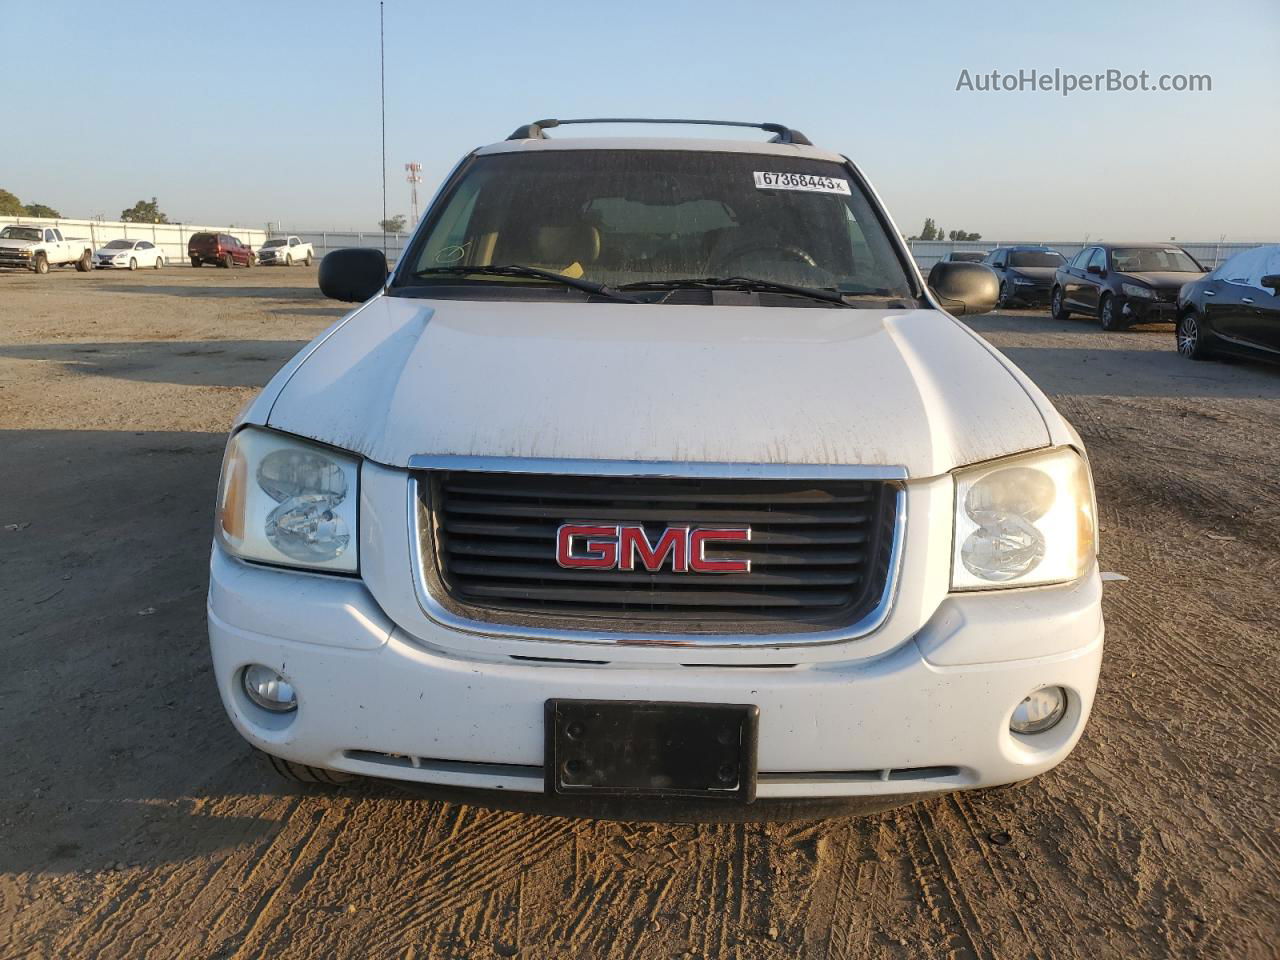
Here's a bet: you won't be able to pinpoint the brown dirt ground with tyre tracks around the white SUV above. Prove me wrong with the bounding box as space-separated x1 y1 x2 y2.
0 268 1280 960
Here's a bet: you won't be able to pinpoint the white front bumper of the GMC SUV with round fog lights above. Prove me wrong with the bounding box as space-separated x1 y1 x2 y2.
209 548 1103 800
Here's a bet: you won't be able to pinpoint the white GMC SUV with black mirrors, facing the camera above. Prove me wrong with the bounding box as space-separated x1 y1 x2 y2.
209 120 1103 818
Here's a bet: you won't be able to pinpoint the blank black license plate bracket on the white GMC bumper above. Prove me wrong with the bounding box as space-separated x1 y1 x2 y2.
545 699 760 804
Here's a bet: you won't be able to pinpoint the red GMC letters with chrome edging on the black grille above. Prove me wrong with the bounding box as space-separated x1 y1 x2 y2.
556 524 751 573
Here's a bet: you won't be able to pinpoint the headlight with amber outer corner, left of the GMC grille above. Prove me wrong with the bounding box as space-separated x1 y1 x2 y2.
215 428 360 573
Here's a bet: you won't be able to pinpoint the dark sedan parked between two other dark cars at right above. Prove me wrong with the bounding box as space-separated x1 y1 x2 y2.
1052 243 1204 330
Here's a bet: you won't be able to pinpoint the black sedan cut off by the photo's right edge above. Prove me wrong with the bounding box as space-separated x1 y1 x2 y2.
1178 243 1280 361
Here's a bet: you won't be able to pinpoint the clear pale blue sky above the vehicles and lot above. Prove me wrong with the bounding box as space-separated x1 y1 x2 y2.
10 0 1280 241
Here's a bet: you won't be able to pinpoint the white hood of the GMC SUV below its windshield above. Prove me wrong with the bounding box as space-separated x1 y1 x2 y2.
268 297 1051 476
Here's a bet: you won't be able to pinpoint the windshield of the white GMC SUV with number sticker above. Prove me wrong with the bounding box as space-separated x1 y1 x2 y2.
397 150 911 298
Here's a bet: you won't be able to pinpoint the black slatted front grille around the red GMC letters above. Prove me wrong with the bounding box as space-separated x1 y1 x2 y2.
419 471 899 634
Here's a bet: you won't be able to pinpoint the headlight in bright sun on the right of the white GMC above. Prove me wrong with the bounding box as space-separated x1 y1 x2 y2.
951 447 1097 590
